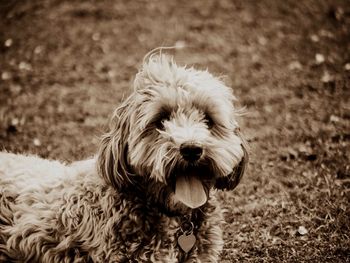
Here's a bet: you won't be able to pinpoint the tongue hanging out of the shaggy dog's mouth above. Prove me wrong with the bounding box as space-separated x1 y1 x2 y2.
175 176 208 208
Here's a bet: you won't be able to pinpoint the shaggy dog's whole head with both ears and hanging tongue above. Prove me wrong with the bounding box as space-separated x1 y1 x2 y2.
99 54 247 214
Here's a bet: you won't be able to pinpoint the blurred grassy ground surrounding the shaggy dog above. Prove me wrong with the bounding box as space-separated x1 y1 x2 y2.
0 0 350 262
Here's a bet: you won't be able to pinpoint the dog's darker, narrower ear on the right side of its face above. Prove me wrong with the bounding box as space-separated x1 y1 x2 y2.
215 131 249 190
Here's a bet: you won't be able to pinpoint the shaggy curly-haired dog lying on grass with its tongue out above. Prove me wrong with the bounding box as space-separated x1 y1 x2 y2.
0 50 247 262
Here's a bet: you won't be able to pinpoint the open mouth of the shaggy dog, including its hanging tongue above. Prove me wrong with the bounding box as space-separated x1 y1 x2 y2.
174 169 213 209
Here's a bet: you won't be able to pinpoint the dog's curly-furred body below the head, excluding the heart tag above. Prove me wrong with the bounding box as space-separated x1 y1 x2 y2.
0 153 223 262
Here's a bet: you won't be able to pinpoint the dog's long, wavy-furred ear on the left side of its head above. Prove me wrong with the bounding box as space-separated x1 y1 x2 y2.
97 99 131 189
